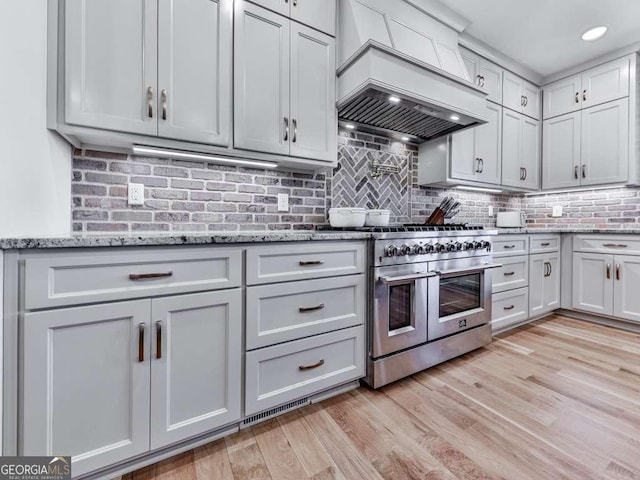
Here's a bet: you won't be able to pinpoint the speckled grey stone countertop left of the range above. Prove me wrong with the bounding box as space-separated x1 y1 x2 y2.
0 230 371 250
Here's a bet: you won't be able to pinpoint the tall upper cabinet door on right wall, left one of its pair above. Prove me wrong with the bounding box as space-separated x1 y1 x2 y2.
542 111 582 189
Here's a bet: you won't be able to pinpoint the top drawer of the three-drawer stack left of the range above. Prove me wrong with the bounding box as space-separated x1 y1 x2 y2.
247 241 365 285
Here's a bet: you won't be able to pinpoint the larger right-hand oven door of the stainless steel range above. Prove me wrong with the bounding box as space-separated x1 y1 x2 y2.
427 260 500 341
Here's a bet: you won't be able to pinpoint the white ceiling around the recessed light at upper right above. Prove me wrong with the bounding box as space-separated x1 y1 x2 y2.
443 0 640 77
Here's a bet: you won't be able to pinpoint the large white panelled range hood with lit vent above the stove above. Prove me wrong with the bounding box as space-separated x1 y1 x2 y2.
338 0 488 143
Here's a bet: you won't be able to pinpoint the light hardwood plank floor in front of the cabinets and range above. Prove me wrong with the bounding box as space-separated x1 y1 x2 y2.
123 316 640 480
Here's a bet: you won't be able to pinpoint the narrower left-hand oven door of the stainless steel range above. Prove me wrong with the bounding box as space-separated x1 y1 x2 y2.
371 263 436 358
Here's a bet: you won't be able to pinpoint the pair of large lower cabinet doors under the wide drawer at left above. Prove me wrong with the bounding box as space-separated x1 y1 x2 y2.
19 289 242 476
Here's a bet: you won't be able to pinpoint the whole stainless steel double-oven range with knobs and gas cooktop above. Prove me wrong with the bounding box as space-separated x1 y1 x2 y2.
365 225 499 388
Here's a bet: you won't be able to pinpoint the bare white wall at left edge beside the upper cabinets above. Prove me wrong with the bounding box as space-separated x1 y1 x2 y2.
0 0 71 237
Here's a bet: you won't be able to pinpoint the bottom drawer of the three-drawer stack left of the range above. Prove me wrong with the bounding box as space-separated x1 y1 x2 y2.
245 325 365 415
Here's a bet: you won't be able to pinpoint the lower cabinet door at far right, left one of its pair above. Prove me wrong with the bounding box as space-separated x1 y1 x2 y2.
573 253 614 315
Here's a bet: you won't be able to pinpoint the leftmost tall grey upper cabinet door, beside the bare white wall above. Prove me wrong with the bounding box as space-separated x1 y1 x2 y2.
64 0 158 135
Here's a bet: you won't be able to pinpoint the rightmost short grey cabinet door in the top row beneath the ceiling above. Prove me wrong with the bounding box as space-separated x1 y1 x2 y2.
581 58 630 108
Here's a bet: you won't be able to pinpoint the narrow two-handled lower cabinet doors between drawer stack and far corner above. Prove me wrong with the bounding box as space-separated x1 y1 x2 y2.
529 252 560 317
